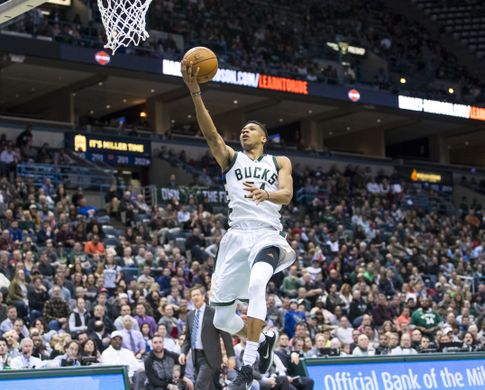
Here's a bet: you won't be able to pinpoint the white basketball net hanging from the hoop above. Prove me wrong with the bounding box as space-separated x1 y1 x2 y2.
98 0 152 54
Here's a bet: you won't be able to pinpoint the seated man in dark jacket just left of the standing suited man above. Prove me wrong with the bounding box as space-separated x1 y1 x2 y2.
145 335 194 390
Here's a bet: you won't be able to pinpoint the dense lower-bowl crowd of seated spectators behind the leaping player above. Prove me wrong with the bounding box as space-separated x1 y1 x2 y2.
0 139 485 389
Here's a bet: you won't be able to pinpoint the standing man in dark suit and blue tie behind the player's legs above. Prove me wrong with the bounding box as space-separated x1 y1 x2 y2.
179 286 236 390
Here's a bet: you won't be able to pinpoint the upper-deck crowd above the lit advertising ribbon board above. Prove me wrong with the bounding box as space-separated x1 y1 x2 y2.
1 0 483 102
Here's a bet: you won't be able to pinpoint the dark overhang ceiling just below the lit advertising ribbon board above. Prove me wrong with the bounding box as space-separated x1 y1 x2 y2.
0 56 485 149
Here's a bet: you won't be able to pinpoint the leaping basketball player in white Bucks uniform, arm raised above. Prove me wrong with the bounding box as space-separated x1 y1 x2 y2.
182 61 296 390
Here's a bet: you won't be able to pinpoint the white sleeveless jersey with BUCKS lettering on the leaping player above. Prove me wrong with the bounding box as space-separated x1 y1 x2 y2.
224 152 282 231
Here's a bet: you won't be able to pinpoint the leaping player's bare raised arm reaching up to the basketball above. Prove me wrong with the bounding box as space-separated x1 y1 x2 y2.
181 61 234 170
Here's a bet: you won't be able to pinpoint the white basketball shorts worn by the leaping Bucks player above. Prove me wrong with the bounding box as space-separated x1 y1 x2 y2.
209 228 296 306
